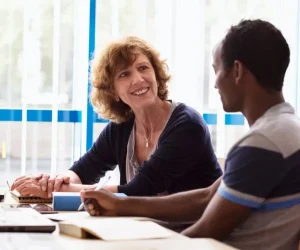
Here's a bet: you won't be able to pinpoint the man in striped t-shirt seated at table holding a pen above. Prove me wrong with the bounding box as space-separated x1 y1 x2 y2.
81 20 300 249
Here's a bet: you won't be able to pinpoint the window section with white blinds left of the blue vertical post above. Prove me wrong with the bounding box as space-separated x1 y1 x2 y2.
0 0 81 183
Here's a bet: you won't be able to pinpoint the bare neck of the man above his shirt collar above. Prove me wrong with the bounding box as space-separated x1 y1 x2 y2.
242 92 285 127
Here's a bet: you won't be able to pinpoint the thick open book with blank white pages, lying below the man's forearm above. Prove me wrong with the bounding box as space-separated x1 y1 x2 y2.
59 217 172 241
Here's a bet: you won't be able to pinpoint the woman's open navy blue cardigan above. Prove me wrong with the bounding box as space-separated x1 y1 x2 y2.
70 103 222 196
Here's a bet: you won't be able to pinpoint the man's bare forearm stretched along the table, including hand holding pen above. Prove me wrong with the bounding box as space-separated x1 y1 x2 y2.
81 178 221 222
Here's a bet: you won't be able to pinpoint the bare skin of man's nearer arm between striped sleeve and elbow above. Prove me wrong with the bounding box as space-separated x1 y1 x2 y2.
182 193 252 240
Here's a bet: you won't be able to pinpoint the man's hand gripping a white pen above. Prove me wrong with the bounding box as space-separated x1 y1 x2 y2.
80 189 124 216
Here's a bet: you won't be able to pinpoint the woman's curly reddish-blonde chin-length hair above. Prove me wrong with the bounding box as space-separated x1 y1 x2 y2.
90 36 171 123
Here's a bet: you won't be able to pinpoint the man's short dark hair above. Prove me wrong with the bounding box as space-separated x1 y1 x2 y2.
222 19 290 91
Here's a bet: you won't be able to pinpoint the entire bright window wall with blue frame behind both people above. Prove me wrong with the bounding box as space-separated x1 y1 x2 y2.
0 0 300 183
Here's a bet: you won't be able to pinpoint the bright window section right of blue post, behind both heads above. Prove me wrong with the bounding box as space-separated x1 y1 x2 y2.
94 0 300 157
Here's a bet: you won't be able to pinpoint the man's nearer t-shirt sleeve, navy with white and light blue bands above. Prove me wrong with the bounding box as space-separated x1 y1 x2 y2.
218 134 289 208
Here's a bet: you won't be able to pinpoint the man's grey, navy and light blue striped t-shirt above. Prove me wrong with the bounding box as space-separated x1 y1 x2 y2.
218 103 300 250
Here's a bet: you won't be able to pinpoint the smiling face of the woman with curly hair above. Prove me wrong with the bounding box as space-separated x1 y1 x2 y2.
114 52 159 110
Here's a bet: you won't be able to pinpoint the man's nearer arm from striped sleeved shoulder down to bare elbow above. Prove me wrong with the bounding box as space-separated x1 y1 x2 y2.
183 134 290 240
